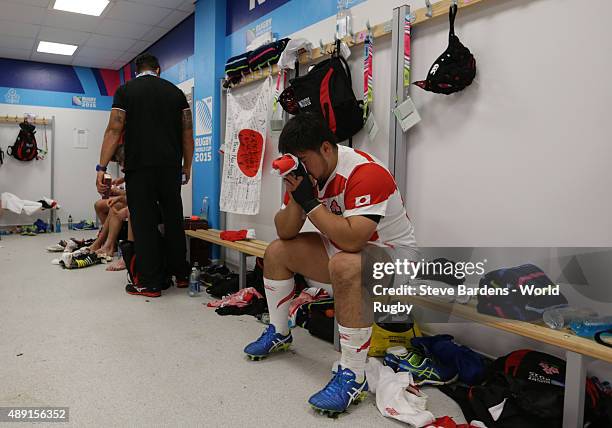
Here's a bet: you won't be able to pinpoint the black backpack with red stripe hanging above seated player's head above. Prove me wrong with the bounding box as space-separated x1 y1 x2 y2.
280 41 363 145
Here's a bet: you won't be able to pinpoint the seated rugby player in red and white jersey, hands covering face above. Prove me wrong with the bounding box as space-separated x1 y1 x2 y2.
244 113 418 415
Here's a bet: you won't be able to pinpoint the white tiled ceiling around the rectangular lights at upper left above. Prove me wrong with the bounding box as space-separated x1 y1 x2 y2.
0 0 195 70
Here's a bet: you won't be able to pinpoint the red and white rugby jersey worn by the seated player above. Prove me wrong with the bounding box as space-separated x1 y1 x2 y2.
284 146 417 247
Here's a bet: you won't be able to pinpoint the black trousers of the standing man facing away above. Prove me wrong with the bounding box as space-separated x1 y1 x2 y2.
125 167 189 289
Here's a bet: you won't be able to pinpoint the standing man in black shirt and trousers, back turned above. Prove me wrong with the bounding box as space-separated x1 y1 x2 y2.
96 53 193 297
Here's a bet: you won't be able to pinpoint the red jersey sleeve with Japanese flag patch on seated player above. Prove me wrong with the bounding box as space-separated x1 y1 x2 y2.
344 163 397 216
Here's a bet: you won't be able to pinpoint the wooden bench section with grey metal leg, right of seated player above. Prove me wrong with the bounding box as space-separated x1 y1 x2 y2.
406 296 612 428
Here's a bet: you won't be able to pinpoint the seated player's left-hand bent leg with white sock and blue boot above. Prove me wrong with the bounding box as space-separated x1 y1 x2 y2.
244 232 330 359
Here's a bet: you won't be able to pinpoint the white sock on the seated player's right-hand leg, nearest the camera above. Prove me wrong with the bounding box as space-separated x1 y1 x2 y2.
338 324 372 382
